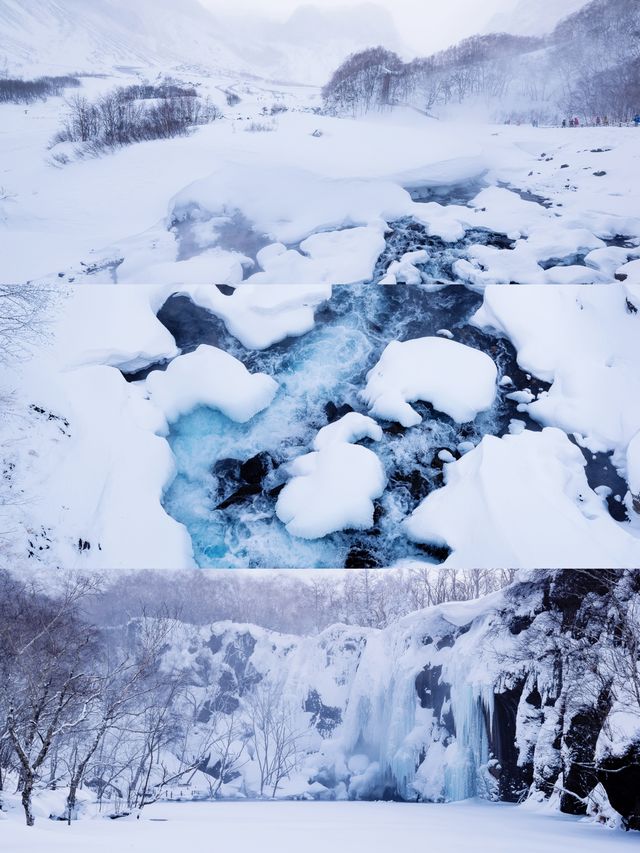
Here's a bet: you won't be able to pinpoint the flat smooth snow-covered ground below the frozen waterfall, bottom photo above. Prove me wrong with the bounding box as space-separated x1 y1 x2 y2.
0 801 637 853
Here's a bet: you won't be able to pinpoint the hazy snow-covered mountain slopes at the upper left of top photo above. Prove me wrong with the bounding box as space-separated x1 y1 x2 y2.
0 0 401 84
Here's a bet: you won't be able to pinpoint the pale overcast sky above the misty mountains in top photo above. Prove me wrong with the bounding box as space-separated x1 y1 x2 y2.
200 0 520 53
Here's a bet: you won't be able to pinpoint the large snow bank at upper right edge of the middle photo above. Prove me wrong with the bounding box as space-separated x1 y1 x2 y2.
472 285 640 452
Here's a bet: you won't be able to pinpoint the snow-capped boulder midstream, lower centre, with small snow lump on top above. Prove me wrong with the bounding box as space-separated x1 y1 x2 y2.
276 412 386 539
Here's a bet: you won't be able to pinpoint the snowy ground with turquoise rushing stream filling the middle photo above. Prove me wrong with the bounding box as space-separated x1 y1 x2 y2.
0 284 640 569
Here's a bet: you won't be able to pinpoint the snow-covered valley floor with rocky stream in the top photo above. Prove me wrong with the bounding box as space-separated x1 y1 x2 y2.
0 69 640 286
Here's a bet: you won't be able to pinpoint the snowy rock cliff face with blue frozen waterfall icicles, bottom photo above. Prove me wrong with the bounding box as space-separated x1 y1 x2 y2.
144 571 640 829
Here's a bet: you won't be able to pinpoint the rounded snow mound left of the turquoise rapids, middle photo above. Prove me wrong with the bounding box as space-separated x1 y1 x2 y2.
146 345 278 423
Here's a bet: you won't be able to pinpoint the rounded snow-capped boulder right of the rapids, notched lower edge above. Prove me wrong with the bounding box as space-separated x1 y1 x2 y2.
362 337 498 427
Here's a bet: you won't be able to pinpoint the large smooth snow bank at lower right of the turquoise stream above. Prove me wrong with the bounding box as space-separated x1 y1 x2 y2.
403 428 640 568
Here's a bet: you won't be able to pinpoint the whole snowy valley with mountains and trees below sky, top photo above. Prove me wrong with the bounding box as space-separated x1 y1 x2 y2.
0 0 640 286
